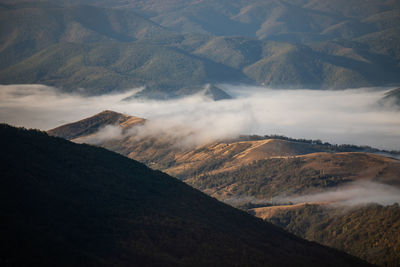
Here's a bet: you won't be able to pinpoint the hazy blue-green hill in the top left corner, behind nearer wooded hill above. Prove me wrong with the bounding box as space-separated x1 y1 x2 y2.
0 1 168 68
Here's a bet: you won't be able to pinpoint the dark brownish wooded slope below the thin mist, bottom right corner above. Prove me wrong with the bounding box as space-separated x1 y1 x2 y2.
268 204 400 266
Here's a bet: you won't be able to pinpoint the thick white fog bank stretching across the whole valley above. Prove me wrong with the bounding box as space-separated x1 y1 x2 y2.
0 85 400 150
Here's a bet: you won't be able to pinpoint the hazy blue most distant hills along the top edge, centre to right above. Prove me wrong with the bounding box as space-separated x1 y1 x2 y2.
33 0 400 42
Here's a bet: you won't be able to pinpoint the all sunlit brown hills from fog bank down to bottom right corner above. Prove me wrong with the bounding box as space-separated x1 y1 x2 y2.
48 111 400 266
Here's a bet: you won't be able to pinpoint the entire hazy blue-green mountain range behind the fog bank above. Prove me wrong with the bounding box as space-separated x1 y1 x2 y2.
0 0 400 99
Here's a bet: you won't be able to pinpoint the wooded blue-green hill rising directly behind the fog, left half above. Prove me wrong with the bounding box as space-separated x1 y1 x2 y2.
0 42 246 98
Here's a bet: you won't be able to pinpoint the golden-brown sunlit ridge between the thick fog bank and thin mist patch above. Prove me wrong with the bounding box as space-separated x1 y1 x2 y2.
49 111 400 205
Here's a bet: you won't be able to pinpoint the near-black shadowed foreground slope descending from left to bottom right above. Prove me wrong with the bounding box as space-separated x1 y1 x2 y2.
0 124 365 266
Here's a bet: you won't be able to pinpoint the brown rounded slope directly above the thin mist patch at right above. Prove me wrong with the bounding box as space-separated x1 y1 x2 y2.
187 153 400 199
